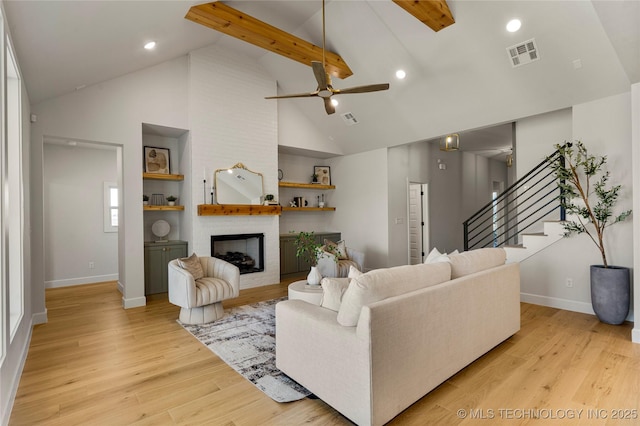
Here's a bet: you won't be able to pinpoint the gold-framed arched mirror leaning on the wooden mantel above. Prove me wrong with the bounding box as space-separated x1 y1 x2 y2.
214 163 264 204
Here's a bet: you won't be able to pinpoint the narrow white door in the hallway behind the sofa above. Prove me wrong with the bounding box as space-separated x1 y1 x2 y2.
407 183 429 265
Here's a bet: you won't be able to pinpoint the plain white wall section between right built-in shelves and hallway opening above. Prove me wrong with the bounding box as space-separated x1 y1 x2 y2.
328 149 389 270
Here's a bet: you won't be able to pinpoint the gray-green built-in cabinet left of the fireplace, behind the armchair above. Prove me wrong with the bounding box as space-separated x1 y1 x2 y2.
144 241 187 294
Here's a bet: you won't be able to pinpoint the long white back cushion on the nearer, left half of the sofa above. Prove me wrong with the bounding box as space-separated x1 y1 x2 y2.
338 262 451 327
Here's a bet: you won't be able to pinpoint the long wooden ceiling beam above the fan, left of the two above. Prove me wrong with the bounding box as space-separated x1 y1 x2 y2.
185 2 353 79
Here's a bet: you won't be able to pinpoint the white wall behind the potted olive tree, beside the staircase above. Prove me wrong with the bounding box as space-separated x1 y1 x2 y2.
517 93 637 320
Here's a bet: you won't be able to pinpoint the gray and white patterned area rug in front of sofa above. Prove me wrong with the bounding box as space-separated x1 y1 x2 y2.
178 297 311 402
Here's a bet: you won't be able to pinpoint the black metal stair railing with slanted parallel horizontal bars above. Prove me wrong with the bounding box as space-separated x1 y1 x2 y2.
463 150 565 251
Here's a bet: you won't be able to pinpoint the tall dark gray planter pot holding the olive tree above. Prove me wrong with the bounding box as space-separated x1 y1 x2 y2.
591 265 631 325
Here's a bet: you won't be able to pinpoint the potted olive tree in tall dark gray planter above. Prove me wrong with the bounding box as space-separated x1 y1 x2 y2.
548 141 631 324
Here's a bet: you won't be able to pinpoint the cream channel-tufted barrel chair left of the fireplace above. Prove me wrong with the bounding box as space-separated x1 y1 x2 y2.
169 256 240 324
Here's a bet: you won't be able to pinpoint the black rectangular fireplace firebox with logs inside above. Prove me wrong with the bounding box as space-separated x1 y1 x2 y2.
211 234 264 274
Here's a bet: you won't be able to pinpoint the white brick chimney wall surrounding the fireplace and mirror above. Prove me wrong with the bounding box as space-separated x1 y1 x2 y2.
189 47 280 288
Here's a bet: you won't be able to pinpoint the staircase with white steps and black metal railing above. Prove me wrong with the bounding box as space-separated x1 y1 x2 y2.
464 146 565 262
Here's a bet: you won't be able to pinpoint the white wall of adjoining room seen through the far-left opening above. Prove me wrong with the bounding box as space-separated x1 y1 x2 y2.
44 143 118 287
